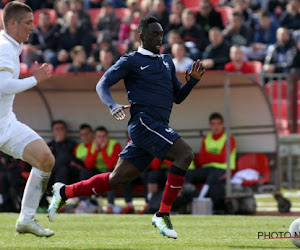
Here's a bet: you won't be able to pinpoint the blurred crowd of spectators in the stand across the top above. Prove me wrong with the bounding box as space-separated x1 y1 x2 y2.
2 0 300 73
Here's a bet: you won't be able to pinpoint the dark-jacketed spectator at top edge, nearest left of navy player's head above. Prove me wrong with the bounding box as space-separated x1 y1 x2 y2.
96 1 121 40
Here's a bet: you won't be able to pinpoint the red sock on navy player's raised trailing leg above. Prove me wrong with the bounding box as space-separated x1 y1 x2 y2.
65 172 112 198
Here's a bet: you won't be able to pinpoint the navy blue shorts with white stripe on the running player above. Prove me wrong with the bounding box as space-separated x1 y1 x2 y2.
120 112 180 172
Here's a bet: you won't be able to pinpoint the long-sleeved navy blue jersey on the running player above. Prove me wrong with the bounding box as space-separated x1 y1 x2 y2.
97 48 198 123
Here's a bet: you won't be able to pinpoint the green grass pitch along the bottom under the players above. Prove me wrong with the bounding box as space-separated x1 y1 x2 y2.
0 213 296 250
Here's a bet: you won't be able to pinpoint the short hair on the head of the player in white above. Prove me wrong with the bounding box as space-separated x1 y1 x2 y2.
2 1 33 27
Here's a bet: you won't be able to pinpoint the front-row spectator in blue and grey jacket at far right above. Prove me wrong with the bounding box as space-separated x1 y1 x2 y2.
263 27 297 73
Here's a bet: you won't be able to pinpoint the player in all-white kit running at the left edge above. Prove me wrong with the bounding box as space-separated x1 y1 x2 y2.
0 1 55 237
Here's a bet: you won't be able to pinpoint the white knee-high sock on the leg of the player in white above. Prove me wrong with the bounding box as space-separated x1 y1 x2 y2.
19 167 51 221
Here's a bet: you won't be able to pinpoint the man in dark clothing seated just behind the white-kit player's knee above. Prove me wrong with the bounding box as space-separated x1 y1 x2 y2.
48 120 78 187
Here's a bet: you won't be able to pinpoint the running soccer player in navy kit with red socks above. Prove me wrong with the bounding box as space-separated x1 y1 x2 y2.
48 17 204 239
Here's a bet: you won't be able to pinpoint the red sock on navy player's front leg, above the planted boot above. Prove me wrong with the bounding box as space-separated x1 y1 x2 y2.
159 173 185 213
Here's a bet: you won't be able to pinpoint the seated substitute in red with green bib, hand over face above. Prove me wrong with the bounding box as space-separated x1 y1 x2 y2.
86 127 134 214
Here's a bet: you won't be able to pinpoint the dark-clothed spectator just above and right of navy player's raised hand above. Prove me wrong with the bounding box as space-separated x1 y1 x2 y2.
202 27 231 70
